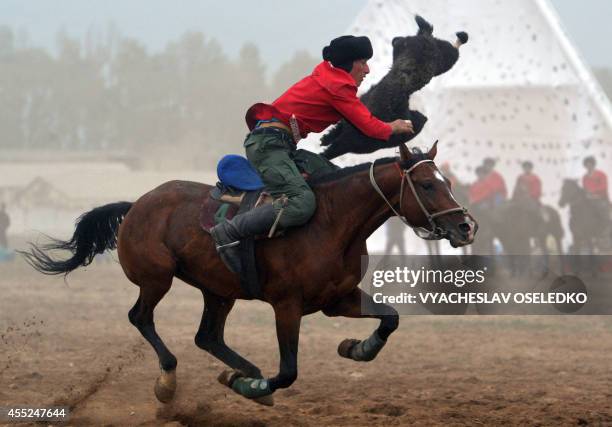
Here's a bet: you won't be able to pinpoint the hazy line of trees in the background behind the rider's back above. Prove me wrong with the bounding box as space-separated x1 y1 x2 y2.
0 27 318 171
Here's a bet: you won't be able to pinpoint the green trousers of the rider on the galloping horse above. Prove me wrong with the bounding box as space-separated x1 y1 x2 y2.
244 131 316 228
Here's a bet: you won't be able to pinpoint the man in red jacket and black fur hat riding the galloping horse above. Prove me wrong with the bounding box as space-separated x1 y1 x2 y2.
210 36 413 270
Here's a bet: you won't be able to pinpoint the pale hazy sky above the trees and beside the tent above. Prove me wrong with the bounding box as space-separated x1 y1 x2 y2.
0 0 612 69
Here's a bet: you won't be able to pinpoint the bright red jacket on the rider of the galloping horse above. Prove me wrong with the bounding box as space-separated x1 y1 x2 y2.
246 61 391 141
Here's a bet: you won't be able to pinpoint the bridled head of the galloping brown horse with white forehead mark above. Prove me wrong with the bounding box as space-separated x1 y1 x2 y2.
400 141 478 247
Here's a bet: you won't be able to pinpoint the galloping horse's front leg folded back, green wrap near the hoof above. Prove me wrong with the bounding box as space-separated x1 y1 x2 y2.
219 299 302 405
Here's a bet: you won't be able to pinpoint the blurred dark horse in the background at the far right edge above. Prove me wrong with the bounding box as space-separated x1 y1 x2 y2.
559 179 612 255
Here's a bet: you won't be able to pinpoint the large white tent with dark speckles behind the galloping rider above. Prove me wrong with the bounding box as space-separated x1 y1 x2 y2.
302 0 612 252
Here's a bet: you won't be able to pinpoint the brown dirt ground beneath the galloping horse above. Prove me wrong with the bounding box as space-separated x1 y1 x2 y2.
0 261 612 426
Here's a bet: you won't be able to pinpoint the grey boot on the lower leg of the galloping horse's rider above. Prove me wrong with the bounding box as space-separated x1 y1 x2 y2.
210 204 276 273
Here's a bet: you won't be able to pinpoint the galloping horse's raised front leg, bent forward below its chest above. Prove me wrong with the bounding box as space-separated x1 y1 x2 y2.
323 288 399 362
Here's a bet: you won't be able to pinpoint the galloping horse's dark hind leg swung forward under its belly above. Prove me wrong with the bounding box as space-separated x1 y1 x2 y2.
195 291 262 378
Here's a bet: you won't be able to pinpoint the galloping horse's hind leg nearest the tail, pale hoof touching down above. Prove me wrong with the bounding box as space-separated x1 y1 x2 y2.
128 276 176 403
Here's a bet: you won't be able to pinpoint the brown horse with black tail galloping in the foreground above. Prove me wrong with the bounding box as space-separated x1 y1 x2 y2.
23 145 477 404
